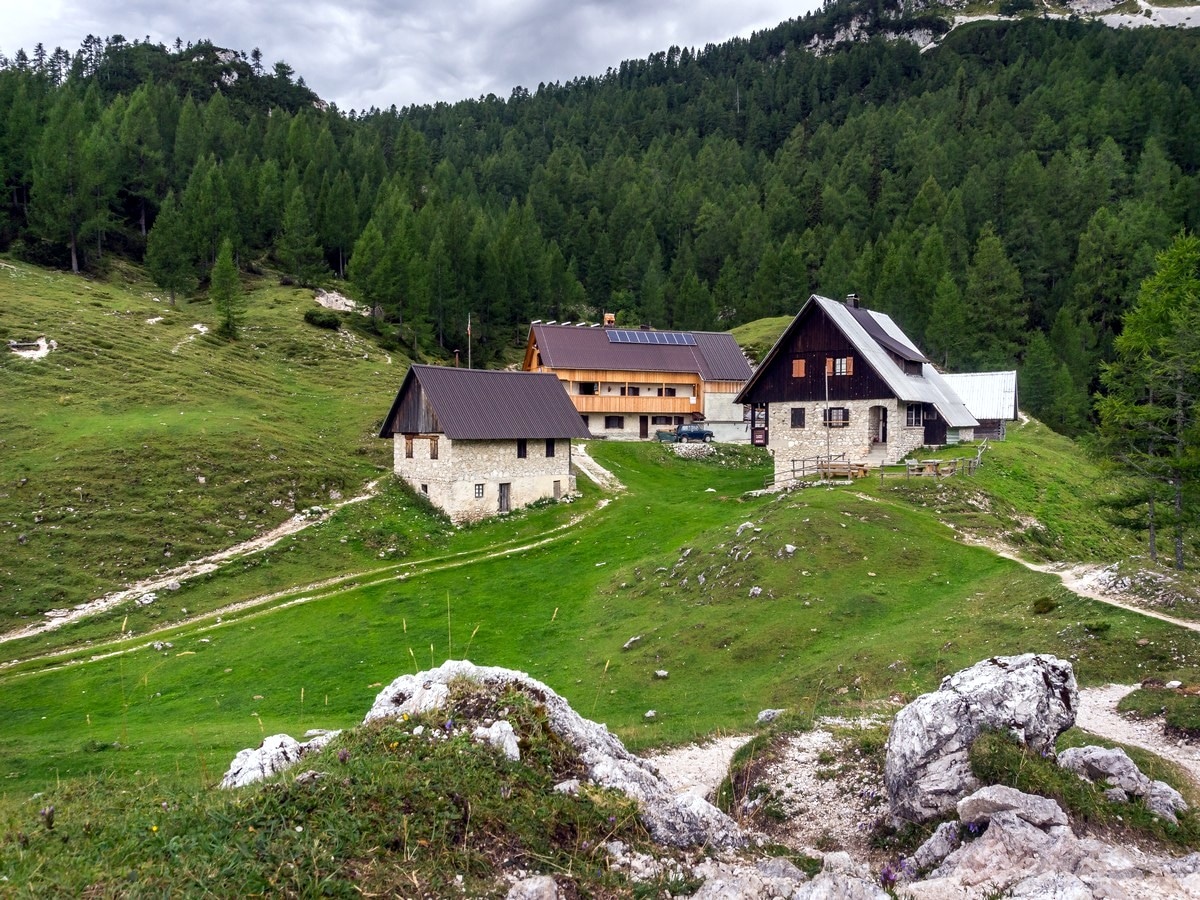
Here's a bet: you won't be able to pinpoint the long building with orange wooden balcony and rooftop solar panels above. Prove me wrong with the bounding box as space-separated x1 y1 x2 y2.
523 323 751 440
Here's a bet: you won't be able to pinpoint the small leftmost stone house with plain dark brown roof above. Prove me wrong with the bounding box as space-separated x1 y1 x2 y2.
379 365 592 521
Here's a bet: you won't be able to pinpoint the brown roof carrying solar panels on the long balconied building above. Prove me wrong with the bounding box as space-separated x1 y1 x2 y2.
530 325 751 382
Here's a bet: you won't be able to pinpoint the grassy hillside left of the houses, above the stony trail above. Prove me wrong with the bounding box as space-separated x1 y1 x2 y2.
0 263 407 630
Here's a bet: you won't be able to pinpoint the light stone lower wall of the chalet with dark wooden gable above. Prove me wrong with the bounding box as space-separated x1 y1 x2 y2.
768 400 925 484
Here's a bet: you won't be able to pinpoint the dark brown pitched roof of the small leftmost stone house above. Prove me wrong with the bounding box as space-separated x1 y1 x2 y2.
379 365 592 440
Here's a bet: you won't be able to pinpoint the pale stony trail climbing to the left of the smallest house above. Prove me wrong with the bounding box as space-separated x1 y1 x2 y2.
0 481 379 643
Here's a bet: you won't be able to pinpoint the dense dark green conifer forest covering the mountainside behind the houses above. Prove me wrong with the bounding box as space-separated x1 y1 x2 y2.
0 5 1200 432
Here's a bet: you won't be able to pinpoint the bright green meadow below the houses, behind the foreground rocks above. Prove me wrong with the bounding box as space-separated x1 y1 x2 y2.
0 443 1200 792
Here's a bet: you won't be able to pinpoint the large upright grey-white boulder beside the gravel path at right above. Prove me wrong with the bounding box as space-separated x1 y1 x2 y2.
884 653 1079 822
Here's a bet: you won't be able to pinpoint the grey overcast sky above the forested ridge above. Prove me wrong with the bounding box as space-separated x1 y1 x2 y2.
0 0 821 110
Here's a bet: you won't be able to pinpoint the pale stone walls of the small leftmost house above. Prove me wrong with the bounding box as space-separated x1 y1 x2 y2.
392 434 575 522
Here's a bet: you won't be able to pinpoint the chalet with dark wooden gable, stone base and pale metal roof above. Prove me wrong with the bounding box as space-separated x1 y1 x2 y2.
734 294 977 484
